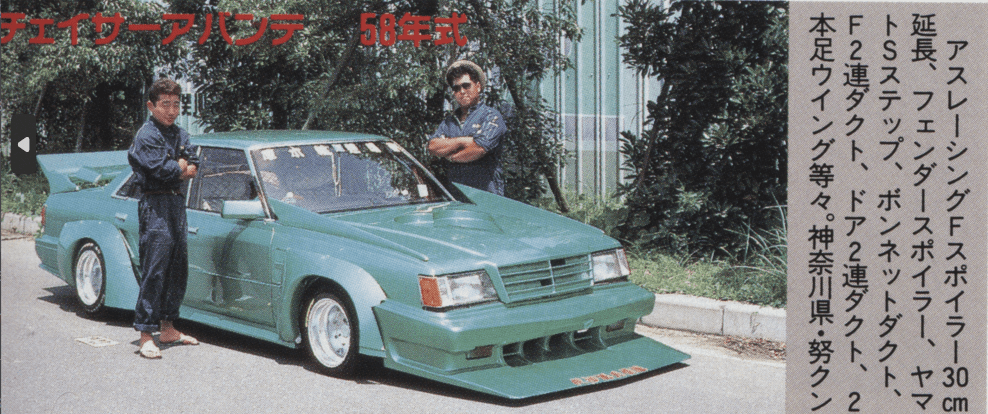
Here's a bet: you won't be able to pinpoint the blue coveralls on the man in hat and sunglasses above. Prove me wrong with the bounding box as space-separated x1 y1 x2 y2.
429 102 508 196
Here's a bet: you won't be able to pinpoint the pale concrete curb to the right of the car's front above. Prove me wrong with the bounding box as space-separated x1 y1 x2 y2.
641 294 786 342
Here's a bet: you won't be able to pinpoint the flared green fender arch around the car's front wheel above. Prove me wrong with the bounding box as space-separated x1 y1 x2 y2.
276 249 387 357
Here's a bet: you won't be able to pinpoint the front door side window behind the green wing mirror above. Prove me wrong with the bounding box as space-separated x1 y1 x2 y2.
189 147 257 212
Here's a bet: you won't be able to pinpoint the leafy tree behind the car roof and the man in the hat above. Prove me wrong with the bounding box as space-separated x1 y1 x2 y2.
180 0 579 205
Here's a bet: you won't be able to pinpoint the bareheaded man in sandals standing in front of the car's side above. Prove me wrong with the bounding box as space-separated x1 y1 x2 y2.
127 78 199 358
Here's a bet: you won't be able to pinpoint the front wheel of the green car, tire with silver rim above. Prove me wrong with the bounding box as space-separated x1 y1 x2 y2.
301 290 360 378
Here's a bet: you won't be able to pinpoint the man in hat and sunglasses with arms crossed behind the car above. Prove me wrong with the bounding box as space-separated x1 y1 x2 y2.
428 60 508 196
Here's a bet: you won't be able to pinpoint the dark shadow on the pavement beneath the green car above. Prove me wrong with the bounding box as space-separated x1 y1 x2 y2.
38 285 688 407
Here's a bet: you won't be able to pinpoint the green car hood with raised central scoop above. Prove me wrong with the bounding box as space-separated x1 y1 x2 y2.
272 199 619 272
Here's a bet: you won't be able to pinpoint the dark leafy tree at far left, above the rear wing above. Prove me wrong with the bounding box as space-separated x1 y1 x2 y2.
0 0 185 152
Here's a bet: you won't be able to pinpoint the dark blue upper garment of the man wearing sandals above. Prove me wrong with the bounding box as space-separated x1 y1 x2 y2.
127 116 199 193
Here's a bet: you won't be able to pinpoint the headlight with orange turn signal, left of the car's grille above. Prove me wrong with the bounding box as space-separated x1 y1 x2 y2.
419 270 497 309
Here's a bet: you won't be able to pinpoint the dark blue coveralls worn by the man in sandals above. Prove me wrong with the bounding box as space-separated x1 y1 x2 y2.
127 116 199 333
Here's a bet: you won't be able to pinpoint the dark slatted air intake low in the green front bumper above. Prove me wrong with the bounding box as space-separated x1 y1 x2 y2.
502 327 604 367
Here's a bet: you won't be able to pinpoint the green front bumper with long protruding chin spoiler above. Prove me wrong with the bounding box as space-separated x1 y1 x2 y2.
374 283 689 398
